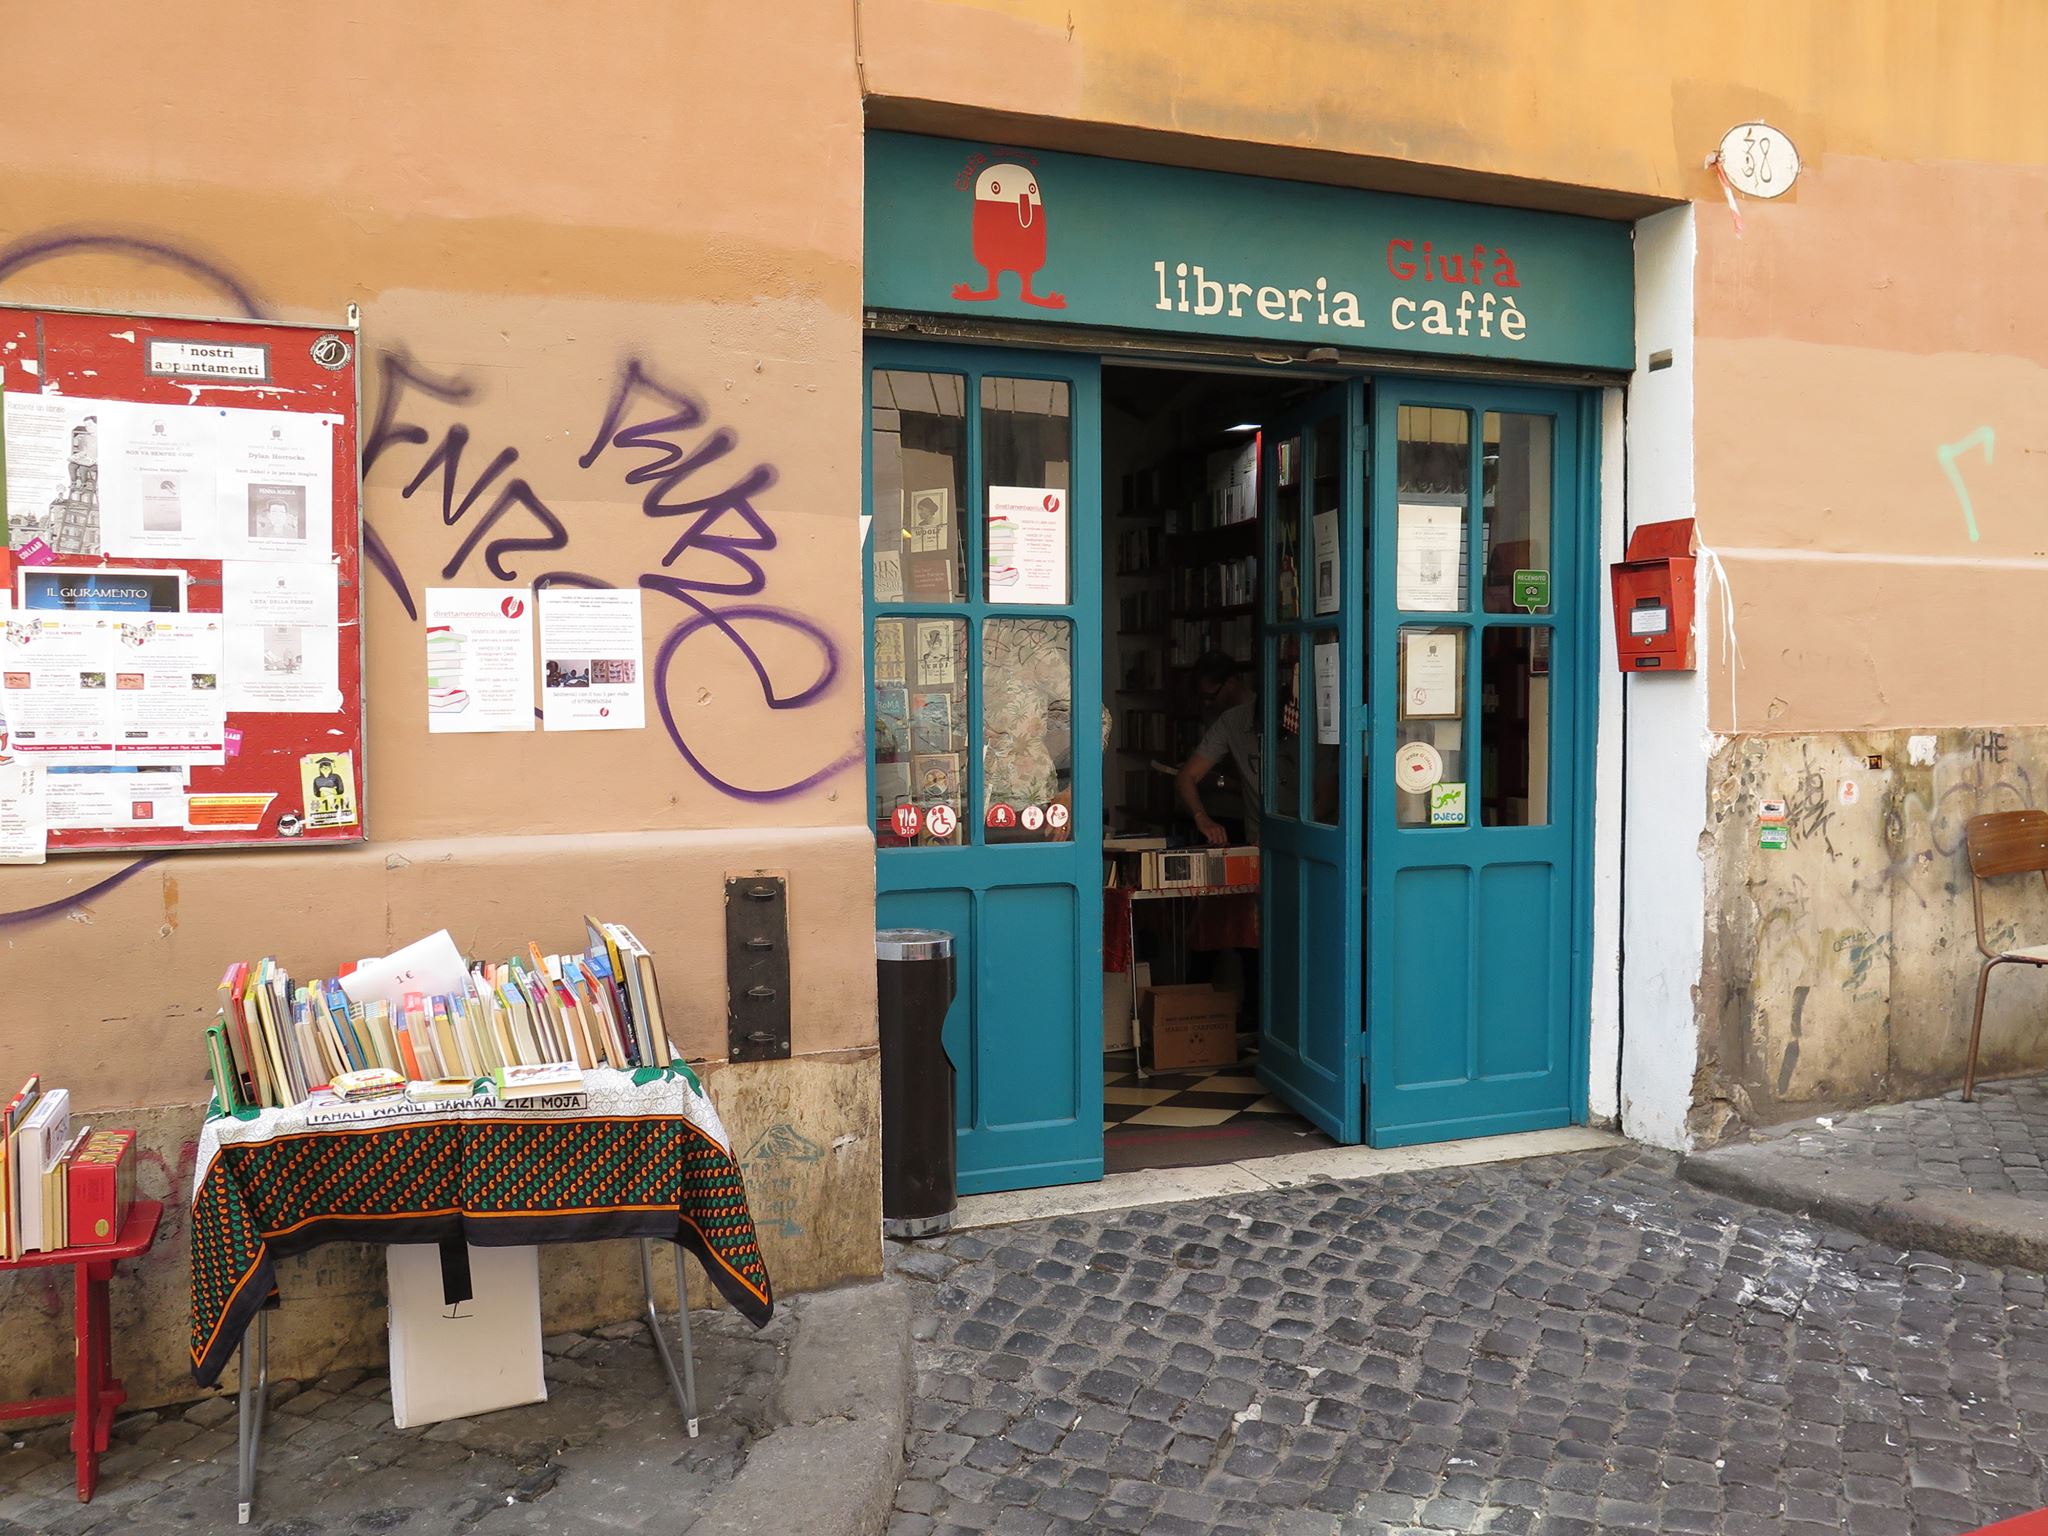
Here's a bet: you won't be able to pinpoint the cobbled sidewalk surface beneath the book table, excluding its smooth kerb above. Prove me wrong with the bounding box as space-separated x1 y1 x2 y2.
0 1311 788 1536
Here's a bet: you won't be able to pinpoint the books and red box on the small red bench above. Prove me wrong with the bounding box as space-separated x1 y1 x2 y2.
0 1077 135 1260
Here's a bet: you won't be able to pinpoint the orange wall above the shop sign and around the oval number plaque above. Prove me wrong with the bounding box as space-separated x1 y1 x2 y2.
860 0 2048 731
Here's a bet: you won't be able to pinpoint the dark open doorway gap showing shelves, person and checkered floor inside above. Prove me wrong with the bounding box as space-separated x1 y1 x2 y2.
1102 365 1333 1174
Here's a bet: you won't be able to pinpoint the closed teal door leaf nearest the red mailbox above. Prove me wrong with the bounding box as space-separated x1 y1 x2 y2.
1366 379 1599 1147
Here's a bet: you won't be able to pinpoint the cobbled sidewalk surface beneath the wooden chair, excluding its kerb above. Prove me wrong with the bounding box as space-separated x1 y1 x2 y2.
1700 1077 2048 1200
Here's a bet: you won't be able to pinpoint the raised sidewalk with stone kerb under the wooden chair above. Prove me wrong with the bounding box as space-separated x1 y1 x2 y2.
1681 1077 2048 1270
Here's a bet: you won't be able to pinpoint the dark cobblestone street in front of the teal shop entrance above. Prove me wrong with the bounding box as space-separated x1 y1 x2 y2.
889 1151 2048 1536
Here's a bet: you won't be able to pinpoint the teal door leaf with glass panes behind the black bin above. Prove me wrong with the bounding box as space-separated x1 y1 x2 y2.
862 342 1102 1194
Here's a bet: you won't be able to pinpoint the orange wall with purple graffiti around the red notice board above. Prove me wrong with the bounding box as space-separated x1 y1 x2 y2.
0 0 874 1108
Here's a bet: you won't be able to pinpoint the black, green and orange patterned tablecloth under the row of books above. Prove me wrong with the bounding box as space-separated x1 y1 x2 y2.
193 1069 774 1386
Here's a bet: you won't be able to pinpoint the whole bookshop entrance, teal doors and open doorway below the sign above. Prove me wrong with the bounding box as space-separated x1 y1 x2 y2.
864 340 1597 1194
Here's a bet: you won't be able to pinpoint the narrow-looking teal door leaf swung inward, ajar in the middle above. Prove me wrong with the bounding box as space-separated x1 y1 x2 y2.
1260 379 1366 1143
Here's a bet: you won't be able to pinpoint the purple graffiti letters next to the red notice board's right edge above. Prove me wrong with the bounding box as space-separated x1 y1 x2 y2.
362 350 569 602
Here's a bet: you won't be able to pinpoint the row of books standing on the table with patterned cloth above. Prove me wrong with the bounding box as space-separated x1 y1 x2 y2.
207 918 674 1112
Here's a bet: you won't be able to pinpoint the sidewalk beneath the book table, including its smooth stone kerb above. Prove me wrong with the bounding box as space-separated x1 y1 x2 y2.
0 1286 909 1536
